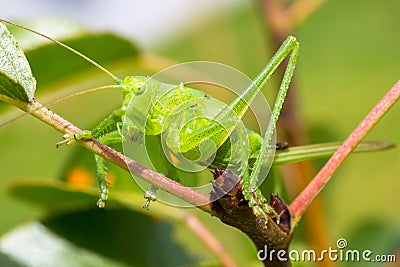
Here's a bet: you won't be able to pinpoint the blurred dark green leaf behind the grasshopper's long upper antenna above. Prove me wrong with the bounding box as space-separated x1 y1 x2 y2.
26 33 139 88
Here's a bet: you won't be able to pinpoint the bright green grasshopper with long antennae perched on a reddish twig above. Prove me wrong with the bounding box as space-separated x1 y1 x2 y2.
0 20 390 223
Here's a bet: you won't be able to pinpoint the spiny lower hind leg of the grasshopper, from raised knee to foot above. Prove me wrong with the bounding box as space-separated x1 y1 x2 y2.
243 36 299 224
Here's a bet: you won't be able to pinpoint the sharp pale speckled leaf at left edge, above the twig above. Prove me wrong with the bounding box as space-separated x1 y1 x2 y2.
0 23 36 102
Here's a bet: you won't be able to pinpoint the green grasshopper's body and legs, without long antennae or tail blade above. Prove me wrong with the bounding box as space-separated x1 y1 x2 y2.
57 36 299 222
